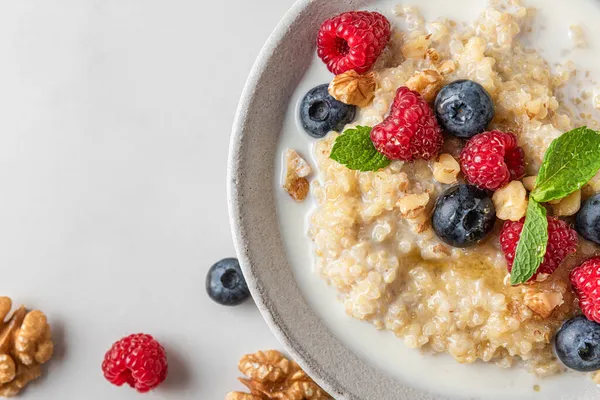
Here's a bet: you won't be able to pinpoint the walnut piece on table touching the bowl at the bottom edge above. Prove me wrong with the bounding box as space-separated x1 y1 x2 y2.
225 350 332 400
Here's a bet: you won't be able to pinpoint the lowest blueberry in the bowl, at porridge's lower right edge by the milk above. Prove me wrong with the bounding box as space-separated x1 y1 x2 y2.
554 315 600 372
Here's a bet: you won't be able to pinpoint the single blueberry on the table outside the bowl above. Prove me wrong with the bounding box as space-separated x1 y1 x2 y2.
206 258 250 306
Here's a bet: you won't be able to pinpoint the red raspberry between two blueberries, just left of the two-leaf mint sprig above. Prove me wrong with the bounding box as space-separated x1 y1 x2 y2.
460 131 525 190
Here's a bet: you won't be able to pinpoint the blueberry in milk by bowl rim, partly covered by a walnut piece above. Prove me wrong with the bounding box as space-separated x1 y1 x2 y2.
300 84 356 138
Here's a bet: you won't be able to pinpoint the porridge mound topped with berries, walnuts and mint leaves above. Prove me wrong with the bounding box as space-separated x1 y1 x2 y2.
282 0 600 379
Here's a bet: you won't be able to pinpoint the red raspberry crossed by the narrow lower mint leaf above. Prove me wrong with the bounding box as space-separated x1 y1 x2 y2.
500 217 577 282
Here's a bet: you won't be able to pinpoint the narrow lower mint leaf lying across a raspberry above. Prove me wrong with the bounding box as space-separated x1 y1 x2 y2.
510 202 548 285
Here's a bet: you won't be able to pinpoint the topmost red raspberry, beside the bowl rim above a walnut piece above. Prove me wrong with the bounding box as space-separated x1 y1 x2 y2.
317 11 391 75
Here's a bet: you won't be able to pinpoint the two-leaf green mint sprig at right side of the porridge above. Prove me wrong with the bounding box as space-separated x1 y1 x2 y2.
510 126 600 285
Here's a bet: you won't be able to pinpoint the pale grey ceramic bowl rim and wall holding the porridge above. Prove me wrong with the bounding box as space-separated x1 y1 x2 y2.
228 0 598 400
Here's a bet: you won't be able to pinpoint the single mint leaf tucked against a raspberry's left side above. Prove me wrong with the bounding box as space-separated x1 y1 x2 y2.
329 126 390 171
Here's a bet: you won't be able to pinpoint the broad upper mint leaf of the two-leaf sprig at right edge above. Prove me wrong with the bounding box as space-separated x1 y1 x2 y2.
531 126 600 203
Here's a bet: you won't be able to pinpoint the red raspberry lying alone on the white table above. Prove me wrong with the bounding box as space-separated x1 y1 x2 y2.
102 333 167 393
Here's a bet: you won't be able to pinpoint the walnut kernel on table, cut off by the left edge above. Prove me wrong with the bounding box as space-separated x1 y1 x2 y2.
0 297 54 397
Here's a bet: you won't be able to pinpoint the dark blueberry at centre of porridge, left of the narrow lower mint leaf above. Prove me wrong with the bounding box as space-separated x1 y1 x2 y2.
431 184 496 247
